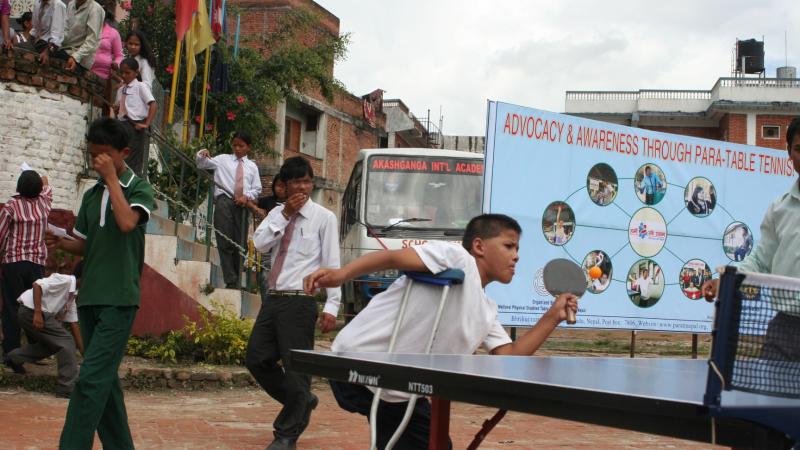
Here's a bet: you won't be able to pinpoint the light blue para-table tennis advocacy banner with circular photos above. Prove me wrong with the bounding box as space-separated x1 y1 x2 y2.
484 101 795 333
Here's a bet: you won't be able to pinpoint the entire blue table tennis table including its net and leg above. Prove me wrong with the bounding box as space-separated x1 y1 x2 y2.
291 271 800 449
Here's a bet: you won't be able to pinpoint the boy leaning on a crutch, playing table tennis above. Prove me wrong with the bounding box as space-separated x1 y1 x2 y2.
304 214 577 449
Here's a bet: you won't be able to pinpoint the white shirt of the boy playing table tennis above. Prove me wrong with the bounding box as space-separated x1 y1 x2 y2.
331 241 511 402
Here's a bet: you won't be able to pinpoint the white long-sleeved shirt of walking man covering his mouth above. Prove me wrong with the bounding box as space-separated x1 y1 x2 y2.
253 199 342 317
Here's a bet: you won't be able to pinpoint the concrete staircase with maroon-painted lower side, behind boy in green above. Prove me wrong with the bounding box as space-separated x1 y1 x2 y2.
133 200 261 335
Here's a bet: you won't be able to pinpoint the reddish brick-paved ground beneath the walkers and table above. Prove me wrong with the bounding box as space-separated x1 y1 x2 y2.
0 383 708 450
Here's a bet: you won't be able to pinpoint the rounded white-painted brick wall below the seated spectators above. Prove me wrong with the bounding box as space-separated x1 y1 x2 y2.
0 50 101 210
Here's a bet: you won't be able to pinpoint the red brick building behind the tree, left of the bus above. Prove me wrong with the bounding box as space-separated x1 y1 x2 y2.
227 0 387 213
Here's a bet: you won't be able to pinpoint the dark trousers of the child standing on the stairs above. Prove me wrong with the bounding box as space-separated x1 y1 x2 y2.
214 194 247 285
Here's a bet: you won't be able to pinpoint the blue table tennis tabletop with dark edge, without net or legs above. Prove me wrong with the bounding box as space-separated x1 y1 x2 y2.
292 351 800 448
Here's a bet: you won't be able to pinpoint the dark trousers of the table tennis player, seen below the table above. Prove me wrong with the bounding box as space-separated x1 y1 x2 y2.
330 381 453 450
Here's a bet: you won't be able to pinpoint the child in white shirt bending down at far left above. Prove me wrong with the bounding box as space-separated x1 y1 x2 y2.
6 263 83 398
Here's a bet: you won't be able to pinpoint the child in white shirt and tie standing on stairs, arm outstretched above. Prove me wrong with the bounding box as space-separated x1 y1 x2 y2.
195 131 261 289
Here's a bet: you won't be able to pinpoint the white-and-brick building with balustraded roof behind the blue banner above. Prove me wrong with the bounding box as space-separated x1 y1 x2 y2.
565 77 800 149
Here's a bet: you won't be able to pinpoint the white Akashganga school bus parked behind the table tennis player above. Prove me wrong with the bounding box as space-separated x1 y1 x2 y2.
339 148 483 320
